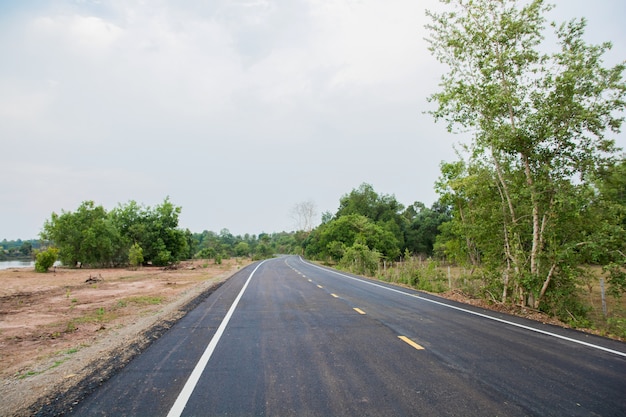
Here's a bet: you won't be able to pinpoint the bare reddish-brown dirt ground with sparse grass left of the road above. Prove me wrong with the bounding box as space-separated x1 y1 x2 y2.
0 259 248 417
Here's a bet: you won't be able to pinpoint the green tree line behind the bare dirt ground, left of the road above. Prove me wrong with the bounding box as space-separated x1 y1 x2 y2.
36 198 304 271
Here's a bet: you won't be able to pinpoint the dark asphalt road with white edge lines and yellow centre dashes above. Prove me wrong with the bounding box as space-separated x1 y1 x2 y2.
70 256 626 417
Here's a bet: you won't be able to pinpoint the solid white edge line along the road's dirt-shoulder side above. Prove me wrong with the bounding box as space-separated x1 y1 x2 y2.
167 261 265 417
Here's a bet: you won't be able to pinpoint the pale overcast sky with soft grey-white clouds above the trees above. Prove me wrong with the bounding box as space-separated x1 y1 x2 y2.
0 0 626 240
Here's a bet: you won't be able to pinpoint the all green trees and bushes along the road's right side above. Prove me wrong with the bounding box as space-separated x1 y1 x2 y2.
306 0 626 335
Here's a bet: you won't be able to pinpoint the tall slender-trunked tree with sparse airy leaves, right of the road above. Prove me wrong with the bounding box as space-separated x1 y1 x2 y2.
427 0 626 308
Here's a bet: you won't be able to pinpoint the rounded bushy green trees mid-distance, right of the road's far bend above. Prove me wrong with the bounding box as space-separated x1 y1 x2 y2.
303 183 450 274
